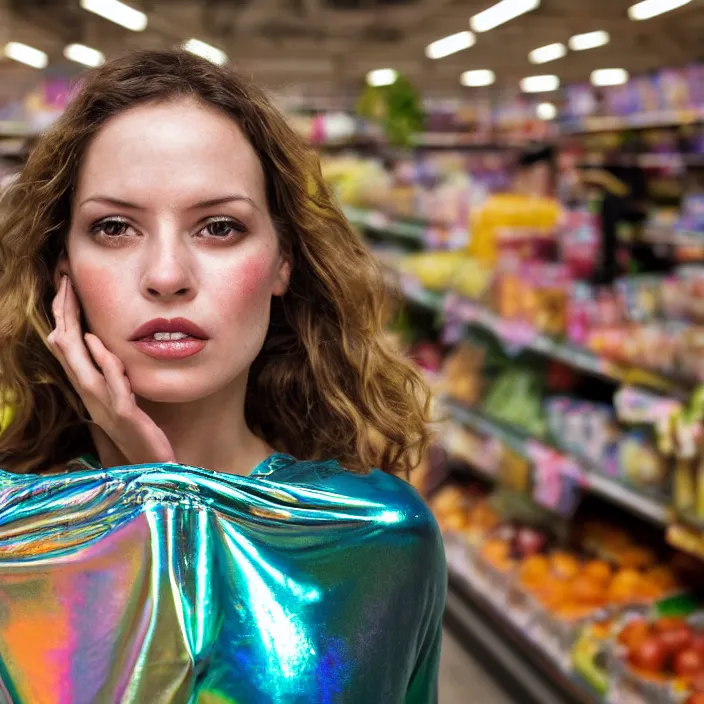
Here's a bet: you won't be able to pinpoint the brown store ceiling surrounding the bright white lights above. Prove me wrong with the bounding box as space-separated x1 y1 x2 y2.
0 0 704 106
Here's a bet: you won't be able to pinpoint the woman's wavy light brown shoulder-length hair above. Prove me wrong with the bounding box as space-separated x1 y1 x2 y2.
0 51 429 472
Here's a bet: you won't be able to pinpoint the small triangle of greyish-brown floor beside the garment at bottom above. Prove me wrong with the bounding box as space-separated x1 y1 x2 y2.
440 630 516 704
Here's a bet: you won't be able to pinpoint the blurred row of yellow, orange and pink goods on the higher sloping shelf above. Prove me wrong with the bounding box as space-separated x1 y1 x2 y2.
398 238 704 381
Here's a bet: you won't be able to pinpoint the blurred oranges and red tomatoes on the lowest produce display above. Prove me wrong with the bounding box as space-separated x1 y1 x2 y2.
429 464 704 704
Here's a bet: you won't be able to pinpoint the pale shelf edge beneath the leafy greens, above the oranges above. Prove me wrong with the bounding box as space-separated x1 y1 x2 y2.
442 398 668 526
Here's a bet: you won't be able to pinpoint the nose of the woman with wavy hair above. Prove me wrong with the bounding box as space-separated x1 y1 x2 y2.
142 237 196 300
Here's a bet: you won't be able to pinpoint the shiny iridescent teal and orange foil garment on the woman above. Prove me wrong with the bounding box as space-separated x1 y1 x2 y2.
0 455 446 704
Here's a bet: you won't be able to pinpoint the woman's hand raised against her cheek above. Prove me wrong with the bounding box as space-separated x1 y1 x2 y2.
47 275 176 466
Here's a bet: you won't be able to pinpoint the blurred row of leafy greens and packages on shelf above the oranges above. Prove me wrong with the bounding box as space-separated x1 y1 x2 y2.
438 340 673 500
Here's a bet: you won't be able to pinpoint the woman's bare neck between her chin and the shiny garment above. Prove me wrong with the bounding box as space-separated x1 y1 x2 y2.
88 388 273 475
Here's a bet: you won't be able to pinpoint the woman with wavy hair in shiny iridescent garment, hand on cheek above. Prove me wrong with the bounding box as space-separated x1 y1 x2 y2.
0 52 445 704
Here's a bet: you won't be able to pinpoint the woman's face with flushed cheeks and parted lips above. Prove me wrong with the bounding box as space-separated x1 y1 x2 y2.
60 99 289 402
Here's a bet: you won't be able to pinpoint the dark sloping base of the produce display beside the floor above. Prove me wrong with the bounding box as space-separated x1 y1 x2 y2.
446 551 602 704
